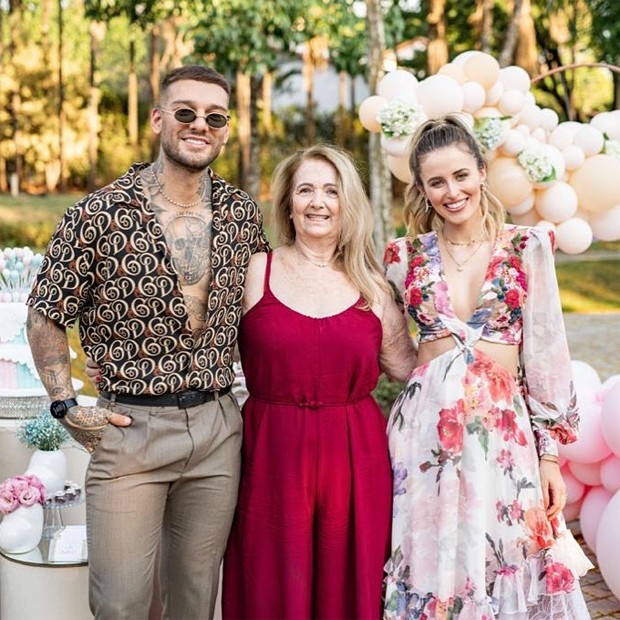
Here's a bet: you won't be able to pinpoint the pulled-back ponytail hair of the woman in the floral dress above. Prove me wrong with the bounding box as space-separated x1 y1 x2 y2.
404 114 506 240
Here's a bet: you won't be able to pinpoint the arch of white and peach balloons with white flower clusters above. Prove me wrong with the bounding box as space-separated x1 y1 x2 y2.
359 51 620 254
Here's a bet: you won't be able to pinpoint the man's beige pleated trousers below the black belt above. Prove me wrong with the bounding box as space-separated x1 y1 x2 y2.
86 394 242 620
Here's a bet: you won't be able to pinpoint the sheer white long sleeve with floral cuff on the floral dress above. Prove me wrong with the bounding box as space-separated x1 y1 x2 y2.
521 228 579 456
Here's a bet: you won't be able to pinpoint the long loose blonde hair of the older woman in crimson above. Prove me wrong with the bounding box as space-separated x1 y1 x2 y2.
271 144 390 309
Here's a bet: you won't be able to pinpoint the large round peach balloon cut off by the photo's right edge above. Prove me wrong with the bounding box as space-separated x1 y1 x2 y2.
570 155 620 213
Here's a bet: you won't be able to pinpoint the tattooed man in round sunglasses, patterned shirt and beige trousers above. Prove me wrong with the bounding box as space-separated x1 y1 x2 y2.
28 66 268 620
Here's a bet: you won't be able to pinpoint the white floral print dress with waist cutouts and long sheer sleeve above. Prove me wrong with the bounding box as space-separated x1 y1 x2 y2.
384 225 591 620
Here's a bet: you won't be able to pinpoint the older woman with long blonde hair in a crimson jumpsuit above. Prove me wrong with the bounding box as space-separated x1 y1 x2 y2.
223 145 413 619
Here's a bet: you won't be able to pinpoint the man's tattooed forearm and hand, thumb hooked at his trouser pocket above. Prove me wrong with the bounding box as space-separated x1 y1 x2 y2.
26 308 131 452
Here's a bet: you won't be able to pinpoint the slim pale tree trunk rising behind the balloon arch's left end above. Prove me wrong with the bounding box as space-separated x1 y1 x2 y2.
366 0 394 259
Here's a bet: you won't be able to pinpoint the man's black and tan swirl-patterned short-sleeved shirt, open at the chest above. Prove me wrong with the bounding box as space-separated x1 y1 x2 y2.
28 164 269 394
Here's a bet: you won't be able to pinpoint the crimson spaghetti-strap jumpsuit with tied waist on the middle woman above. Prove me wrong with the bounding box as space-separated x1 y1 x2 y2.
222 254 392 620
